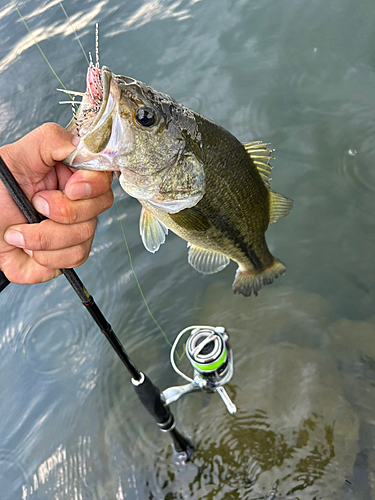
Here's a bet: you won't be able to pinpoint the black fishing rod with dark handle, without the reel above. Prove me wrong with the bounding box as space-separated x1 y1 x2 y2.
0 156 193 462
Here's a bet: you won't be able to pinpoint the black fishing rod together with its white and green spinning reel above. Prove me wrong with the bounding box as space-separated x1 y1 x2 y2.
0 156 237 463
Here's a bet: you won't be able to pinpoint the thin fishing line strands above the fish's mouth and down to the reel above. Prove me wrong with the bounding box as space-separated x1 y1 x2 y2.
12 0 173 350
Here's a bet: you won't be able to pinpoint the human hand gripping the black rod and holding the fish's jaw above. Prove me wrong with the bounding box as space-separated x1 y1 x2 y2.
0 123 113 284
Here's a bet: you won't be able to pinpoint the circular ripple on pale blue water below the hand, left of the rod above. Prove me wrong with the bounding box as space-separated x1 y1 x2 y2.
23 306 87 375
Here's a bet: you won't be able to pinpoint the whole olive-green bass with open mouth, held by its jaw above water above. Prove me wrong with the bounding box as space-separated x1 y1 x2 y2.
65 62 293 297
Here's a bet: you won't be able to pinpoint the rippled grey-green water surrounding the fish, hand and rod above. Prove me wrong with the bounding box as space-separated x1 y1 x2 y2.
0 0 375 500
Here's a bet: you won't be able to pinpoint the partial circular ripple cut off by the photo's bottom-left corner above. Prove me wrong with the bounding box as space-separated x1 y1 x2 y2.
0 449 26 500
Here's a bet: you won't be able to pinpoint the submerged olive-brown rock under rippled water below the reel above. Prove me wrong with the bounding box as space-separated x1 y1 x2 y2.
146 344 359 500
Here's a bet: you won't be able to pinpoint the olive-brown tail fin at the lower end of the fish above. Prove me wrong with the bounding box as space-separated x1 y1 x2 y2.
233 259 286 297
